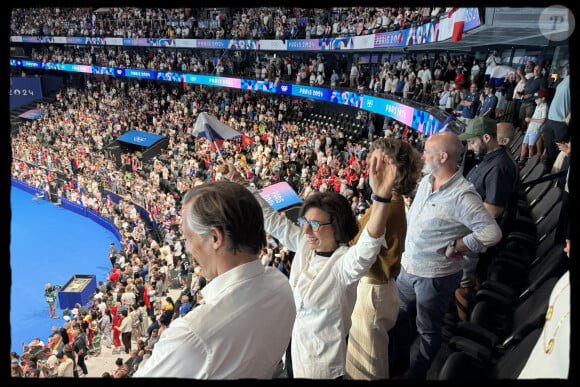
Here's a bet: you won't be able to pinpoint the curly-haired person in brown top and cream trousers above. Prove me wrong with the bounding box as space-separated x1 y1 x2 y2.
345 138 423 380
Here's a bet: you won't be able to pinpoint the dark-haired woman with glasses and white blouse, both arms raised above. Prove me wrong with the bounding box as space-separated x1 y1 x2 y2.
223 150 397 379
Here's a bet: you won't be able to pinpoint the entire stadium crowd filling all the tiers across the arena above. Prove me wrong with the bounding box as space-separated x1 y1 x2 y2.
11 8 572 378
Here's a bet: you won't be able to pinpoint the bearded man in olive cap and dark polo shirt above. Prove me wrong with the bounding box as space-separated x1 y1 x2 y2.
455 117 518 320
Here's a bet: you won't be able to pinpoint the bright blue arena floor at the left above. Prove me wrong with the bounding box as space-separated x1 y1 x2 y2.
10 187 118 354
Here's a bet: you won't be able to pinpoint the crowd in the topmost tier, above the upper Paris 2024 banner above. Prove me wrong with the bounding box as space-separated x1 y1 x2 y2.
11 7 449 39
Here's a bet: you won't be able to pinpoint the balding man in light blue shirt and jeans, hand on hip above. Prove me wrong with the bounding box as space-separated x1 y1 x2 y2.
391 132 501 380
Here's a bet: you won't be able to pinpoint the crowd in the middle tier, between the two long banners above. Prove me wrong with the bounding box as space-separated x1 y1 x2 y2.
22 40 554 141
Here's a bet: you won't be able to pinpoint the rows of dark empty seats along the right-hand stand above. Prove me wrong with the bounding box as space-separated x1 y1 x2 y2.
439 131 569 380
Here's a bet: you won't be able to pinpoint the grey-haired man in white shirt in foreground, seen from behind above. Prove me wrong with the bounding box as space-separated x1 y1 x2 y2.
134 182 295 379
